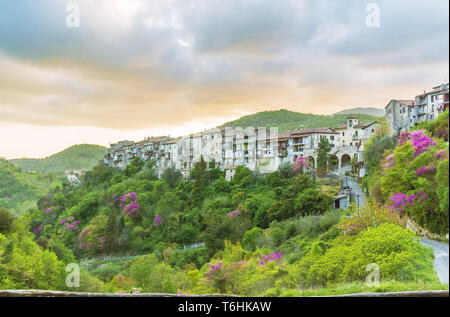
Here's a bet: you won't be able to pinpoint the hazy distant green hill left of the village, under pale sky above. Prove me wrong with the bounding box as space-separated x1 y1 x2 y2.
10 144 107 173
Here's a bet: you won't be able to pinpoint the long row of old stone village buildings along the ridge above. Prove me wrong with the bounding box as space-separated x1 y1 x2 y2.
103 83 449 180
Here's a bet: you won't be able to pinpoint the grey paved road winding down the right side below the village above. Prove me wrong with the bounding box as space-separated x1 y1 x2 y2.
340 175 449 284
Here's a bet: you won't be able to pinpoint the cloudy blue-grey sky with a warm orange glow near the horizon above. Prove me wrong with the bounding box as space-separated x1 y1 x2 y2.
0 0 449 158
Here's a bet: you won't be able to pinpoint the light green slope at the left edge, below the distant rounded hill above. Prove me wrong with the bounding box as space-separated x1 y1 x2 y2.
0 159 61 215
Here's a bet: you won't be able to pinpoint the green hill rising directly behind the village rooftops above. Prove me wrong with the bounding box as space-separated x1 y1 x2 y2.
220 109 380 132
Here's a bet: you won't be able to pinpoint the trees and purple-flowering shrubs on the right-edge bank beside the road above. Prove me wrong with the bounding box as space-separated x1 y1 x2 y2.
365 111 449 235
